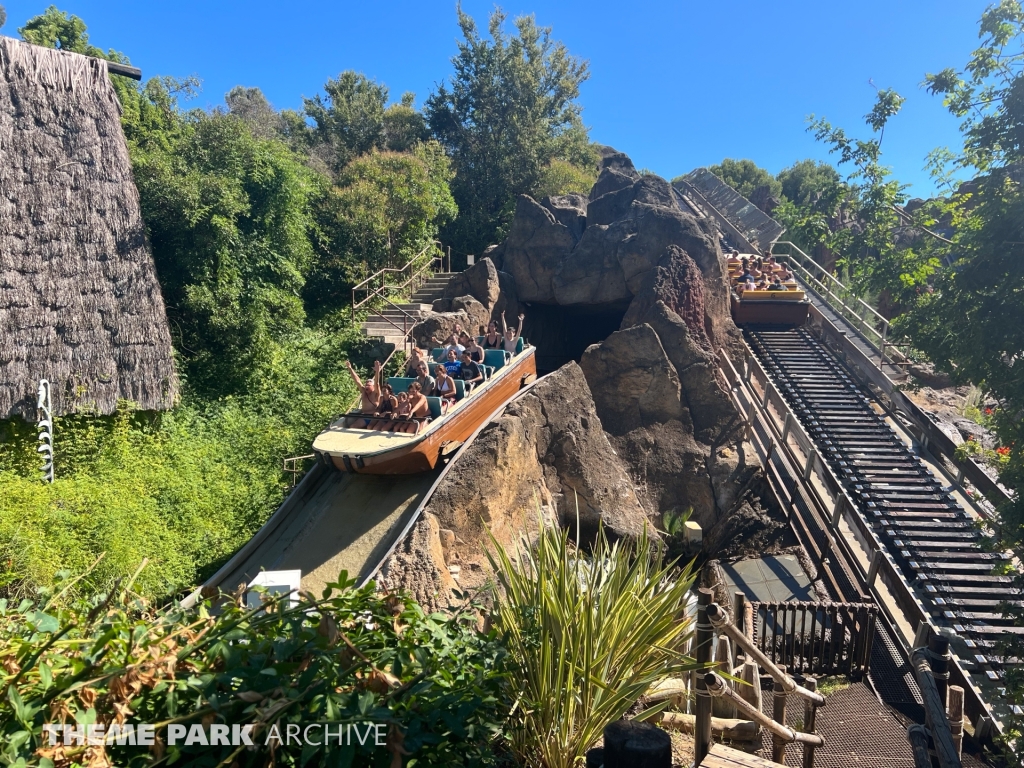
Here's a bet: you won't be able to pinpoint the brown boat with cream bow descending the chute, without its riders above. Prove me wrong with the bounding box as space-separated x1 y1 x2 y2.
313 345 537 475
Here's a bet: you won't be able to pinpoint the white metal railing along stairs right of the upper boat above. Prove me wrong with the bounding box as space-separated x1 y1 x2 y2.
772 240 910 370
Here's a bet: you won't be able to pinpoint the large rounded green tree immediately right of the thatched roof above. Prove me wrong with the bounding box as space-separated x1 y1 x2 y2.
132 107 315 395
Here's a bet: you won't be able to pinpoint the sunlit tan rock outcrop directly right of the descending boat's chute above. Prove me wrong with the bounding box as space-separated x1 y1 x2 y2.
383 362 647 607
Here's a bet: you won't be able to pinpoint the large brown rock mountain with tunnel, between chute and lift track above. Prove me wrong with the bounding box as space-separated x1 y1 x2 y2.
390 150 784 614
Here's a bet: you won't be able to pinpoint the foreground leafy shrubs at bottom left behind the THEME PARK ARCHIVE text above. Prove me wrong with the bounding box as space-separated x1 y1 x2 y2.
0 571 508 768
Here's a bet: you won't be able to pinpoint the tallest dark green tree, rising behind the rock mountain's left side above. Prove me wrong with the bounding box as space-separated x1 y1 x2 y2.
425 7 596 253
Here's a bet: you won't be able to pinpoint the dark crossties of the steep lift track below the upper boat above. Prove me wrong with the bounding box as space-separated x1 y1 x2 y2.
744 329 1024 683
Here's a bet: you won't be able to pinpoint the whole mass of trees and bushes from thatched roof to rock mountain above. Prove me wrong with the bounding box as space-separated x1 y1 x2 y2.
0 6 596 596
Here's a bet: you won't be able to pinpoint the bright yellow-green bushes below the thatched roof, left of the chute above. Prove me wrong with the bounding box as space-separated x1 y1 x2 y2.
0 323 354 597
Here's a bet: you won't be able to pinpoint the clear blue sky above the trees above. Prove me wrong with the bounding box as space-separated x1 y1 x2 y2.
0 0 988 195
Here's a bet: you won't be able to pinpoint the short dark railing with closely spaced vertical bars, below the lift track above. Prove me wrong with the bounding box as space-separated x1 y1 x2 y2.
752 601 878 679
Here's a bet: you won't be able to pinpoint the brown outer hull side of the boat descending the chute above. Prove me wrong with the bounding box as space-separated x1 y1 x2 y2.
322 347 537 475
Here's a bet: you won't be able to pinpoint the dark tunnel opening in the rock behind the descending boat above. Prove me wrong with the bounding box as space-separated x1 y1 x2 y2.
522 301 629 374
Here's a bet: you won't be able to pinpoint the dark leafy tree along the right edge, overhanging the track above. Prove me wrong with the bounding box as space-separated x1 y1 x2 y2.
899 6 1024 753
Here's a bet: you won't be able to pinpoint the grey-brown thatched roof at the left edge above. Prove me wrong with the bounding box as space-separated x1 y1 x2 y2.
0 37 177 419
